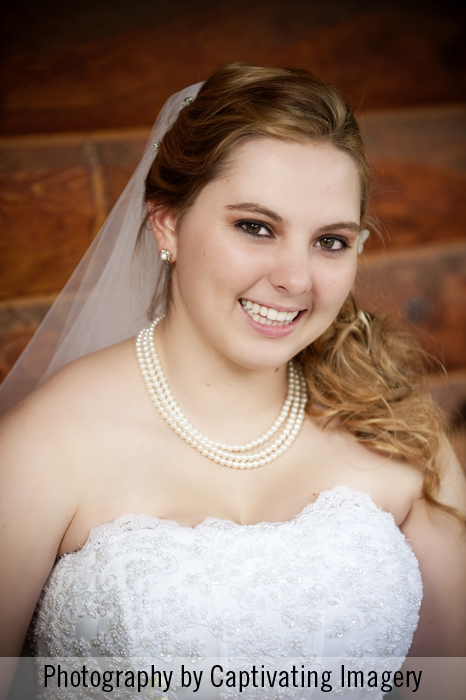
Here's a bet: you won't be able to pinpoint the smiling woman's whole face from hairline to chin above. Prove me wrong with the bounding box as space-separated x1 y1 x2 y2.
163 139 360 368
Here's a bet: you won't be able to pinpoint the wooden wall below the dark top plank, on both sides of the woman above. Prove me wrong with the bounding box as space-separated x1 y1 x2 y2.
0 106 466 432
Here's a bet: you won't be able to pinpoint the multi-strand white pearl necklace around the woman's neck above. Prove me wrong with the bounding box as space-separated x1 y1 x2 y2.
136 316 307 469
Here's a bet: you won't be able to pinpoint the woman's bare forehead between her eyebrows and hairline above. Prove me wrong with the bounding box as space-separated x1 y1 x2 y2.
193 138 360 218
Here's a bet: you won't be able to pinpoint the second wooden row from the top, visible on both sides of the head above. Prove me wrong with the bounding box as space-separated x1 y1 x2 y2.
0 105 466 299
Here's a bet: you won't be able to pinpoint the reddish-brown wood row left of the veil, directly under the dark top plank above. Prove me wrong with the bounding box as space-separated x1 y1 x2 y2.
0 130 147 300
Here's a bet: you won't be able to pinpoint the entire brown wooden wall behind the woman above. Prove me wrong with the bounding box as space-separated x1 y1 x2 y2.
0 0 466 463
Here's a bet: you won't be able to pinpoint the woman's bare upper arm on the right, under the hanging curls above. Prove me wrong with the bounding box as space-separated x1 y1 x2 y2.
401 443 466 656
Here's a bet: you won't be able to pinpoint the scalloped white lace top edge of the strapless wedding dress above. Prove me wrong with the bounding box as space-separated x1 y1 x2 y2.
55 484 404 562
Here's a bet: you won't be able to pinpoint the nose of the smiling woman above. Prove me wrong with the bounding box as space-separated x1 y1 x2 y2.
269 245 312 296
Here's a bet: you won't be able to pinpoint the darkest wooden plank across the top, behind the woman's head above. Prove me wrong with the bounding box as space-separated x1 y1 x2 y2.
0 0 466 135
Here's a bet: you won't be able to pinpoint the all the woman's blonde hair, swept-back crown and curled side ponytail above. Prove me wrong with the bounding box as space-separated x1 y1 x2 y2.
138 63 466 524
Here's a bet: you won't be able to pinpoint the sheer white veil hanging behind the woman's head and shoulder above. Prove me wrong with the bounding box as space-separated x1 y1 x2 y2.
0 83 202 415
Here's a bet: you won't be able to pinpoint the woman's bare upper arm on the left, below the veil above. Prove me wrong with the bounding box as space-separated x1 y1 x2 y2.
0 388 81 656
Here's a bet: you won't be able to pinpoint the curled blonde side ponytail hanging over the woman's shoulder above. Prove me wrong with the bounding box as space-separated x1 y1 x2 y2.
298 293 466 526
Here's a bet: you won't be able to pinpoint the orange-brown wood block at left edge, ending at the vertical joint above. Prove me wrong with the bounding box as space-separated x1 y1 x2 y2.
0 166 94 298
